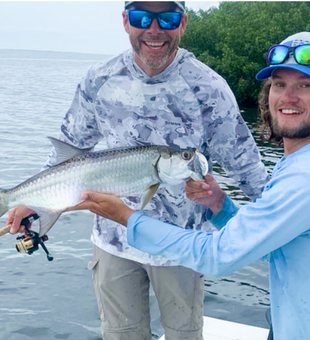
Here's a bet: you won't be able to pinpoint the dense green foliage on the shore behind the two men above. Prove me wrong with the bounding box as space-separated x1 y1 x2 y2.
181 1 310 106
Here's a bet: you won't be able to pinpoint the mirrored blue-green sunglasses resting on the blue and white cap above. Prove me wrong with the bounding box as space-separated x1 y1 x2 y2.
267 44 310 66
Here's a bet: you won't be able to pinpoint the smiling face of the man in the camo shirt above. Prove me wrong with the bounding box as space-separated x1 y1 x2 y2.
123 1 187 76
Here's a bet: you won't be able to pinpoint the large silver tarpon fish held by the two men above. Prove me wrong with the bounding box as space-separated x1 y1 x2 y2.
0 137 208 236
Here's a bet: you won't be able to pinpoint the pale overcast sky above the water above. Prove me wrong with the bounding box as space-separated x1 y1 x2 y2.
0 0 219 55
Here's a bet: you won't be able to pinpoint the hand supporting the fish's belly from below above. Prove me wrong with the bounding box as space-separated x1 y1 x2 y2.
66 191 135 226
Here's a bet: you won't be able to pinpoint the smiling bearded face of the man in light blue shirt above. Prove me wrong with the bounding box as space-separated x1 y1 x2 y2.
269 69 310 153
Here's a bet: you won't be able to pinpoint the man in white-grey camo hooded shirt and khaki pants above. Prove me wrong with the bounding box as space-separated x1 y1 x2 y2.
9 1 267 340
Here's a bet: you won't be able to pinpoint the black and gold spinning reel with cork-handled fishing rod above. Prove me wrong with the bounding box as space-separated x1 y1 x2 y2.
0 214 53 261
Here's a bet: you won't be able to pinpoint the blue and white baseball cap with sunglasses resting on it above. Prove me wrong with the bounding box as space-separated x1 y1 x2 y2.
256 32 310 80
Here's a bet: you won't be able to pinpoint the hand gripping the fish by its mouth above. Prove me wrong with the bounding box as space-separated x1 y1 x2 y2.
185 174 226 215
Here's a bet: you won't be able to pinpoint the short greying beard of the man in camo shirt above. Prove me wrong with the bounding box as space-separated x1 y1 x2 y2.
130 34 180 70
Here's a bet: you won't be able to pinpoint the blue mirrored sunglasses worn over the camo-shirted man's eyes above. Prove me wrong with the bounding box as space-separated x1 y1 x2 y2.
127 9 183 30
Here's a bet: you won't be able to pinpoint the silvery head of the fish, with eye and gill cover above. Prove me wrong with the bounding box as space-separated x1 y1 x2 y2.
157 147 208 185
